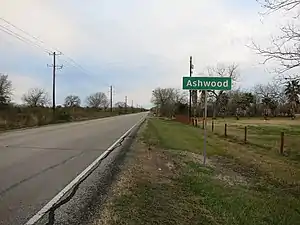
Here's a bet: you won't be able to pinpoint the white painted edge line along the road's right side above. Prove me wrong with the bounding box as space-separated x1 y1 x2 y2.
24 116 146 225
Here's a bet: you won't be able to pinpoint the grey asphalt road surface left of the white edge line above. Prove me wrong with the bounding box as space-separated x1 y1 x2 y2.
0 113 146 225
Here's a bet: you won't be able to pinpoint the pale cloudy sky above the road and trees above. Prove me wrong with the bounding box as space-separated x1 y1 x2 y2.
0 0 281 107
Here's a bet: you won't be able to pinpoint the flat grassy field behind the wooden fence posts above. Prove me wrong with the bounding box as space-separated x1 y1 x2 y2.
208 118 300 162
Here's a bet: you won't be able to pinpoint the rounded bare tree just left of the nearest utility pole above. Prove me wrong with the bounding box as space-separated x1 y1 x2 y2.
22 88 50 107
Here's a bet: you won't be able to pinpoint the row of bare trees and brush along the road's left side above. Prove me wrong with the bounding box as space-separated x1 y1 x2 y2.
0 74 145 130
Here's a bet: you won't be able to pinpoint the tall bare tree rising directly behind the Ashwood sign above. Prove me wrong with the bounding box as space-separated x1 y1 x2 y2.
208 63 239 117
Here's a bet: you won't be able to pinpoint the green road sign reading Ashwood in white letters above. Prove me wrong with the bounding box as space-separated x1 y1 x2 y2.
182 77 232 91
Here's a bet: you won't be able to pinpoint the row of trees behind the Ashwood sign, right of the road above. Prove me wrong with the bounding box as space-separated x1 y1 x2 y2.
151 64 300 119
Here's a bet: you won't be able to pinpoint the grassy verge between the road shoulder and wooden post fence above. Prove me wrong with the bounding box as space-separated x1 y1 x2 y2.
94 119 300 225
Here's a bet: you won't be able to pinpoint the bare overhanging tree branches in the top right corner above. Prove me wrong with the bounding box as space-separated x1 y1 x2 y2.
250 0 300 74
